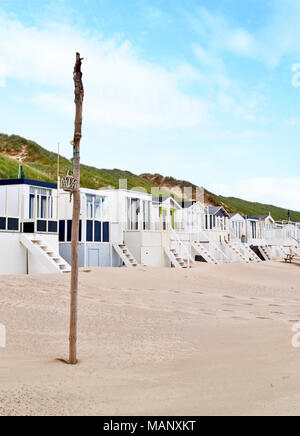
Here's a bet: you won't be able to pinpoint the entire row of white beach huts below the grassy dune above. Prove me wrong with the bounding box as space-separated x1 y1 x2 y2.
0 179 300 274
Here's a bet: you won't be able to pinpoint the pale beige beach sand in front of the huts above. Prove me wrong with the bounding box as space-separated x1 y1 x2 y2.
0 262 300 415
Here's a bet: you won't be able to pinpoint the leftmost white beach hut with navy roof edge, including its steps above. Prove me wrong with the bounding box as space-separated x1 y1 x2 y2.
0 179 70 274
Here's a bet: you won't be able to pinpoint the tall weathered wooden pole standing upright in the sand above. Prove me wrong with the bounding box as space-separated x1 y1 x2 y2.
69 53 84 365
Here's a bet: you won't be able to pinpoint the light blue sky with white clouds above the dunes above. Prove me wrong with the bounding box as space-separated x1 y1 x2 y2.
0 0 300 210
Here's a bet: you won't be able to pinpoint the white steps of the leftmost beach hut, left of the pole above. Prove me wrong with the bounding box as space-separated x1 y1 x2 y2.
20 233 71 273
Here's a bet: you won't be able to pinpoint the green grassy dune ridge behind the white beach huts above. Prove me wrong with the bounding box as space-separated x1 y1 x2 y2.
0 134 300 222
